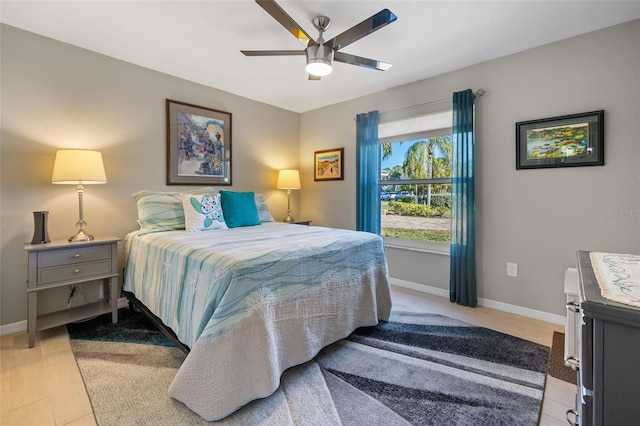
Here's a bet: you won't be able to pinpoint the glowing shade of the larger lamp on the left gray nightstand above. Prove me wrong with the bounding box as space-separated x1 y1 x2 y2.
51 149 107 185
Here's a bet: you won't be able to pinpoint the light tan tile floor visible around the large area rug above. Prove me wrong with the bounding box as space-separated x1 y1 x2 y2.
0 287 575 426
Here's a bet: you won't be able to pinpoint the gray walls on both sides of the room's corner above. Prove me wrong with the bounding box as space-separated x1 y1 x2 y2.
0 21 640 325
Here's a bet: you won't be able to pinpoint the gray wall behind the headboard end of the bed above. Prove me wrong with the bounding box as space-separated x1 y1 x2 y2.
0 25 299 325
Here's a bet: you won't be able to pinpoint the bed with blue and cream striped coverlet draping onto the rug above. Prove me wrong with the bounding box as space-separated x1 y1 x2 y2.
124 189 391 420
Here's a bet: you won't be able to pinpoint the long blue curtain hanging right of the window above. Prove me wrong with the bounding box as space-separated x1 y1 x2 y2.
449 89 478 306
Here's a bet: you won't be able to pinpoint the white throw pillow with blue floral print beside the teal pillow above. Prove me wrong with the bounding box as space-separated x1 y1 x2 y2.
181 194 227 232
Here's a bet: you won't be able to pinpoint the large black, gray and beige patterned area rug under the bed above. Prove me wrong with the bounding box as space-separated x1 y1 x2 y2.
68 310 549 426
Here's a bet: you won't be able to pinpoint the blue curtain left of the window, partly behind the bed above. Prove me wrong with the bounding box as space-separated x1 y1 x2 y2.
356 111 380 234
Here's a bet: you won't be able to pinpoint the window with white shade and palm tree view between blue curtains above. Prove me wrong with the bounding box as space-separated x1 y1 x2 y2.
378 110 453 252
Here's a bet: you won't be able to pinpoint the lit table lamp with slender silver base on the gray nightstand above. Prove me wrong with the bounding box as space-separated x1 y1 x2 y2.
51 149 107 243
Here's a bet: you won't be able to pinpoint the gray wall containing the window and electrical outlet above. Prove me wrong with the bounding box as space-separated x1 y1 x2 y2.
300 21 640 315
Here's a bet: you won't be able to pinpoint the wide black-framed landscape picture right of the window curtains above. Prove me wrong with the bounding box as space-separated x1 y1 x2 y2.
516 110 604 170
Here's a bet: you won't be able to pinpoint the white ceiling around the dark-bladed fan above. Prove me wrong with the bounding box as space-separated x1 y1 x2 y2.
0 0 640 112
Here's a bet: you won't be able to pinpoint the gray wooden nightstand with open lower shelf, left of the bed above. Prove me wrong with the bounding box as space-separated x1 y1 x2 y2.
24 237 120 348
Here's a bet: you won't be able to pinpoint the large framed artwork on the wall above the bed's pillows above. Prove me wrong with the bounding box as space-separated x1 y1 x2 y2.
166 99 231 186
